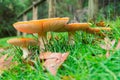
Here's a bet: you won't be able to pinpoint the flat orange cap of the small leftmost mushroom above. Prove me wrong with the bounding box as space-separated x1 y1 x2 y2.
7 38 37 47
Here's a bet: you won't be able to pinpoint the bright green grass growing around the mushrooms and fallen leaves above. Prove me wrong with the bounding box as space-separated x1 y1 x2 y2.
0 18 120 80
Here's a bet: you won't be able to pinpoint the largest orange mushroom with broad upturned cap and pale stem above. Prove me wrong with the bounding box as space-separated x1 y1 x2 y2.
13 17 69 52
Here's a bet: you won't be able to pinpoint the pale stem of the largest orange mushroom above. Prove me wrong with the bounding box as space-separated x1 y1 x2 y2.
38 32 47 52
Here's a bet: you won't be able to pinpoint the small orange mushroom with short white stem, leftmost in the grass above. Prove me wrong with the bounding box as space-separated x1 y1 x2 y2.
7 38 37 59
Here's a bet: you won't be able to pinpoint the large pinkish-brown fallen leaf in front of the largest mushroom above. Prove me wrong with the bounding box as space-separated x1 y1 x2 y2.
40 52 69 75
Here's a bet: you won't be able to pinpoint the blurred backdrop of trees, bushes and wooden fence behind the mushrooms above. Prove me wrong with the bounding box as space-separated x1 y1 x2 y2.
0 0 120 38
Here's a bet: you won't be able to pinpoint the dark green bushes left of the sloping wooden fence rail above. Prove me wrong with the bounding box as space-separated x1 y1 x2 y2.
0 0 32 37
